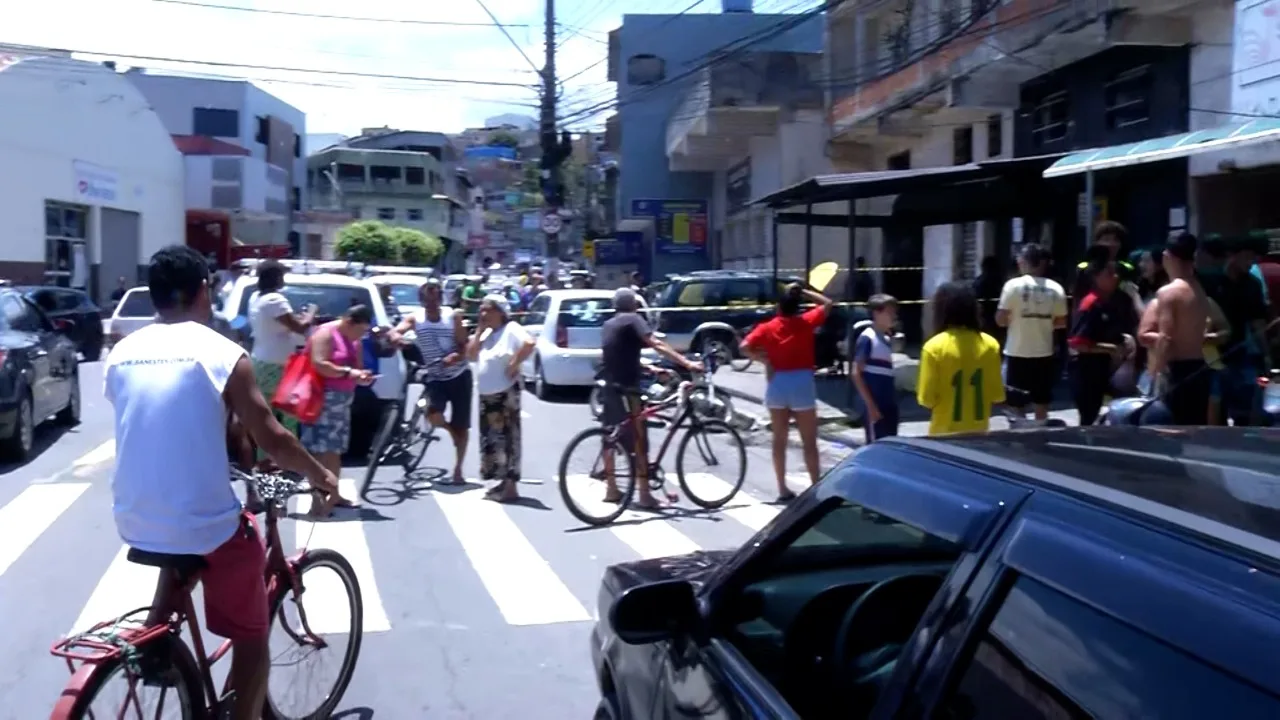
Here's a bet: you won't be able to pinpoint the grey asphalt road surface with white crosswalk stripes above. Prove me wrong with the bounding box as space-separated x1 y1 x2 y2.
0 363 847 720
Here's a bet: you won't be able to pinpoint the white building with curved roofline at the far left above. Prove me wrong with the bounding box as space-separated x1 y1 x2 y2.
0 54 186 300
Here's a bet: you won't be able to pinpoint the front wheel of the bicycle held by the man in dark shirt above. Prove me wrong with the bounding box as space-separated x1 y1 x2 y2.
676 420 746 510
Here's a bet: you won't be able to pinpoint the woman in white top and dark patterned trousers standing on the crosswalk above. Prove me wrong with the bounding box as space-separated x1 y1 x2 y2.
467 295 534 502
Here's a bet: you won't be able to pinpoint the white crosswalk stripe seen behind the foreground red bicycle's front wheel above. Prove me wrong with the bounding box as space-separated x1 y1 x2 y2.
294 478 392 634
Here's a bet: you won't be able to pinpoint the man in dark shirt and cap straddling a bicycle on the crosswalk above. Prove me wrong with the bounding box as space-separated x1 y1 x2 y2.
600 287 703 510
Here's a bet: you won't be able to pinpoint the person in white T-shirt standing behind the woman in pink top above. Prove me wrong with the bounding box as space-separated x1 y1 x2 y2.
248 260 316 438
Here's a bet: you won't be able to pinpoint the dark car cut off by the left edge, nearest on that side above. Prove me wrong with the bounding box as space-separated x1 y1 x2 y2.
0 288 81 461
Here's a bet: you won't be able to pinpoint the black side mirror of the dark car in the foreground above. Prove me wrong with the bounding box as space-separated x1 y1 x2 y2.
609 580 701 644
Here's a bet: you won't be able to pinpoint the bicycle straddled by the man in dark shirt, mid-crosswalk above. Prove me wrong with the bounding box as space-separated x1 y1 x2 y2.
559 371 746 525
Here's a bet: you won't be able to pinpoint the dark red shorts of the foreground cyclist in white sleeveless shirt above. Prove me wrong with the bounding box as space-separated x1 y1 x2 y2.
200 512 271 642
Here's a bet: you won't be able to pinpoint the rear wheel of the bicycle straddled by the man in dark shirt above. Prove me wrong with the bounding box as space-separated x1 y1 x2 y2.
559 428 636 525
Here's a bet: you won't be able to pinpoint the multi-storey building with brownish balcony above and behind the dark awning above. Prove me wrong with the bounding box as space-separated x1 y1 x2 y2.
827 0 1194 308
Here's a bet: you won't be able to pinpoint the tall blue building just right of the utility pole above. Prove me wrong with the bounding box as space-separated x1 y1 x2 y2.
607 3 823 278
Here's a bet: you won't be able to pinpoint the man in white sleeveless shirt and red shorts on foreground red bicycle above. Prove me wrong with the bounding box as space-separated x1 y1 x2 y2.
104 246 338 720
